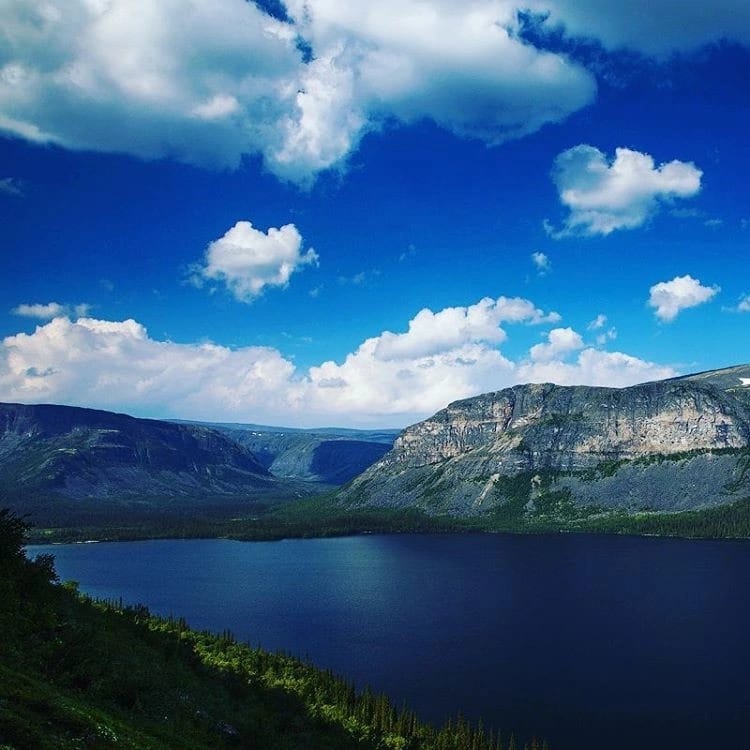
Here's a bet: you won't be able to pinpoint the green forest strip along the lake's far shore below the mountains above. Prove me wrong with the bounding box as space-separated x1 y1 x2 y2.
20 448 750 543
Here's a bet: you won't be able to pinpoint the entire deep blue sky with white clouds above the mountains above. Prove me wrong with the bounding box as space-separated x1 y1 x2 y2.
0 0 750 428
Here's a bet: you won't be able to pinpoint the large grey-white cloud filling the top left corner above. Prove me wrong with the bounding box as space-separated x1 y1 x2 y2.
0 0 300 167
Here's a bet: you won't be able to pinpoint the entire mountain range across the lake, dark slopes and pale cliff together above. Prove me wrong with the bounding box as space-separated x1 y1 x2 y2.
5 365 750 534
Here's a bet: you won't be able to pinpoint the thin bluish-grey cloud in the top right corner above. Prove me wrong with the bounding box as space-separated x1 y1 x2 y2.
525 0 750 56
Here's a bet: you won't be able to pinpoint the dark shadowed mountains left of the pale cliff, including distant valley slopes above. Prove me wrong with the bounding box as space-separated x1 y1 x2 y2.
0 404 396 524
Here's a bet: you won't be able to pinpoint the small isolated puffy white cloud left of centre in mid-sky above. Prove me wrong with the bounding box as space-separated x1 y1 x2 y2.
193 221 318 302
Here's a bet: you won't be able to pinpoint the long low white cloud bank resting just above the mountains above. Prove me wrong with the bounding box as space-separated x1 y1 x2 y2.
0 297 675 426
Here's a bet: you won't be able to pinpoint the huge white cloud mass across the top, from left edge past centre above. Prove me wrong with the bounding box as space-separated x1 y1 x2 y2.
0 0 595 183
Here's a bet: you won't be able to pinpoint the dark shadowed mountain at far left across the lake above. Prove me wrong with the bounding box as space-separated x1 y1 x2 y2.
0 404 299 521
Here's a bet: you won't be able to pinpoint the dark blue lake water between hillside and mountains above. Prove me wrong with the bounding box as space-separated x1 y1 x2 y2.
30 535 750 750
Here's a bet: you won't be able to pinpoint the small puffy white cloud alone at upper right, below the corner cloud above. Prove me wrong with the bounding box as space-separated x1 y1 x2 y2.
551 144 703 237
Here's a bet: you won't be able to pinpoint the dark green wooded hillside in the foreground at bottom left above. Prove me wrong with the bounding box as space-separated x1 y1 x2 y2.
0 510 546 750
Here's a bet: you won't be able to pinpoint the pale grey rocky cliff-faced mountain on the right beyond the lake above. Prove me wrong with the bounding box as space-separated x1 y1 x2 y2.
338 365 750 520
